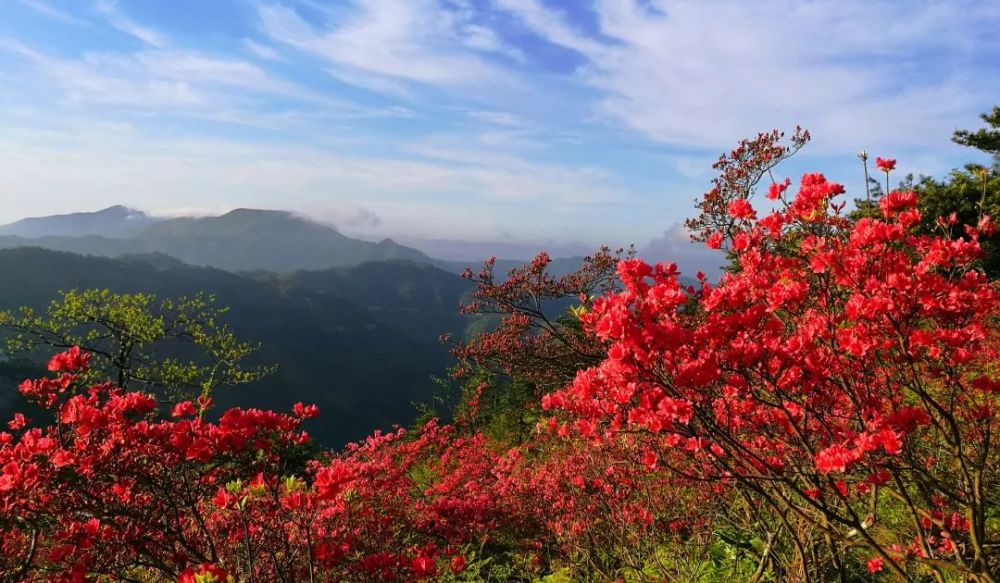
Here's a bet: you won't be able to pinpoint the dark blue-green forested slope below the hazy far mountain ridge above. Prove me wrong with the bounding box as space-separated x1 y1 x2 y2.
0 248 470 445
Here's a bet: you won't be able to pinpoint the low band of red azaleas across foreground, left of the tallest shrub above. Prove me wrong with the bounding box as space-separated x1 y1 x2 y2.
0 351 697 583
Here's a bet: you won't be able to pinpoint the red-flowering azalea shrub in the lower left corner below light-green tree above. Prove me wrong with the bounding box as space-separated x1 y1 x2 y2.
0 348 306 580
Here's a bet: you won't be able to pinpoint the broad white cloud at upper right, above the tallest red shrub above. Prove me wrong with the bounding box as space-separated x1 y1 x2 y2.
494 0 1000 151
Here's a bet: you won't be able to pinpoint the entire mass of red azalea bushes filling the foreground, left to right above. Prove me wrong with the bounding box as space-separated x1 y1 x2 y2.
0 133 1000 583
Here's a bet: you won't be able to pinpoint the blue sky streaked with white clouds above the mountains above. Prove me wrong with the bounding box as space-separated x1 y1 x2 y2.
0 0 1000 245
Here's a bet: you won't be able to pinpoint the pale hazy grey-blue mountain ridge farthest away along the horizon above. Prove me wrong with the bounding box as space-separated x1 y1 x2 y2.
0 206 724 278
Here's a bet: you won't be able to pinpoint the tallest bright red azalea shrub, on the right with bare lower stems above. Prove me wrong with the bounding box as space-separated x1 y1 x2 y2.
543 167 1000 581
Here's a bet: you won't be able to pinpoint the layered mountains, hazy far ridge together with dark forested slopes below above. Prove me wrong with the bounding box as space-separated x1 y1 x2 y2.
0 206 720 446
